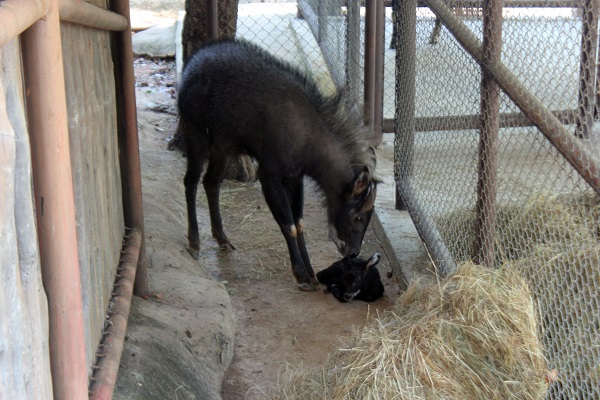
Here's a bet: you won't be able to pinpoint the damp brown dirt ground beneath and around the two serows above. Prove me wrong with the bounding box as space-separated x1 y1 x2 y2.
134 54 399 400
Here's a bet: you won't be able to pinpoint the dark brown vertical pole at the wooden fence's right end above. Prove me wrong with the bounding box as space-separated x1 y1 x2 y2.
112 0 148 295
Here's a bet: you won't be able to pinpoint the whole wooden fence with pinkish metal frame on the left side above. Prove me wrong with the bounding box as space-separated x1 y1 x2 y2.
0 0 147 399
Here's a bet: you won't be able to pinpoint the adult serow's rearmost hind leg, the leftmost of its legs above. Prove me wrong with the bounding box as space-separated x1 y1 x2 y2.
183 141 206 260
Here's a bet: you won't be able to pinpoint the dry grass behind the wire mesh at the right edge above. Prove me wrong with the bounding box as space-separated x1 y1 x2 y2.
438 193 600 398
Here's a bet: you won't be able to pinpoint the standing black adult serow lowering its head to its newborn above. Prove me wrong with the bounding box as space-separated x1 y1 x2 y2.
177 40 376 290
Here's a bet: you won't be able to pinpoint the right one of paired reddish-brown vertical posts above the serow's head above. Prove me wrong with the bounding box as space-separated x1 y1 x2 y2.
373 0 385 146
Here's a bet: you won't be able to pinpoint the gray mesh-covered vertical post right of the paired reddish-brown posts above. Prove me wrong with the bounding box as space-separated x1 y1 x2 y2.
394 0 417 210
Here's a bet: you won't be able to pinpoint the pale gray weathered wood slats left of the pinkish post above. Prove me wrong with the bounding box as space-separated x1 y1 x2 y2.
0 39 52 400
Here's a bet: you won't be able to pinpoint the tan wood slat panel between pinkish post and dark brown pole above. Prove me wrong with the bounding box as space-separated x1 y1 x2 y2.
62 14 124 366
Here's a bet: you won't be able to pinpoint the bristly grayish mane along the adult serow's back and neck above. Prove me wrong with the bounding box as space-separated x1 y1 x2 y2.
208 39 376 174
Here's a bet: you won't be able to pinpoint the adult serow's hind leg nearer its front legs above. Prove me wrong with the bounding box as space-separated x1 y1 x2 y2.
202 152 235 250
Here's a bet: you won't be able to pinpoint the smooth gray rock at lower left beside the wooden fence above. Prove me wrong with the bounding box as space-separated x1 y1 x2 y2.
113 278 234 400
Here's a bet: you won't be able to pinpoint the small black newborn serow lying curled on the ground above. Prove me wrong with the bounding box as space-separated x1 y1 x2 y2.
317 253 383 303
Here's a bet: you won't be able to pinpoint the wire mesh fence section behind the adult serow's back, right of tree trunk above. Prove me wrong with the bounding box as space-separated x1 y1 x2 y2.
219 0 370 112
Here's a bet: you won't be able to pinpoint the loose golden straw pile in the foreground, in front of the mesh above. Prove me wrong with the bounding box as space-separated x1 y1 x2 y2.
270 263 547 400
